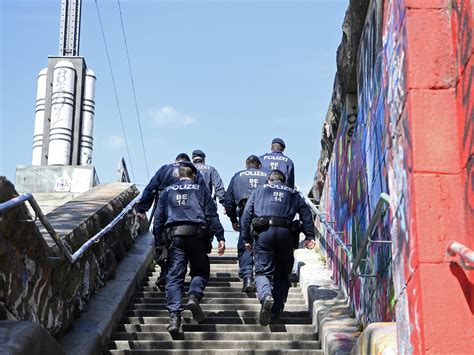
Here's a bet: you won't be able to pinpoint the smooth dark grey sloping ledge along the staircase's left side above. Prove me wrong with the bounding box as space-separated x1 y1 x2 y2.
60 232 155 355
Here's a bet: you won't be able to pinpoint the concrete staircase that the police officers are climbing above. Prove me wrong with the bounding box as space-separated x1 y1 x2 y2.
106 249 323 355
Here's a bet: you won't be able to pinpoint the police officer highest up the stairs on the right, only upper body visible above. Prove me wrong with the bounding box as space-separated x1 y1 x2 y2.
260 138 295 189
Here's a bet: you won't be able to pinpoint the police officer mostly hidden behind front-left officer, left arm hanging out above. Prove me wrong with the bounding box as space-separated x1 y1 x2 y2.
137 153 204 286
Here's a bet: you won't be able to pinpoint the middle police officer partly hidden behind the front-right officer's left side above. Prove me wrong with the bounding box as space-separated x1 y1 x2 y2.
224 155 267 292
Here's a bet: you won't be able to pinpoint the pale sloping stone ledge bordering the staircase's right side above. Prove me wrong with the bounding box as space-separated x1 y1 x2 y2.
295 249 360 354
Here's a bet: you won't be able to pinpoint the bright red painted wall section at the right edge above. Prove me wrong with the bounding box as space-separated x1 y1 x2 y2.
400 0 474 354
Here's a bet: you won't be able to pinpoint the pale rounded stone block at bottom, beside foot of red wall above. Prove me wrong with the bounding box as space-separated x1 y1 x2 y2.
352 322 398 355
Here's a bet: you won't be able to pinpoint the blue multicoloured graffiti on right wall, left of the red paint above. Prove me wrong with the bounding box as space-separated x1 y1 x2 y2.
322 0 394 324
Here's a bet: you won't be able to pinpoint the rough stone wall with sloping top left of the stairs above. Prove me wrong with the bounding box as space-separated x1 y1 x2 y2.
0 177 144 337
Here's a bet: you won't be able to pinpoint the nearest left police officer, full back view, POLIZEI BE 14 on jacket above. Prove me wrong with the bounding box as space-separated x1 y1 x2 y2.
154 161 225 333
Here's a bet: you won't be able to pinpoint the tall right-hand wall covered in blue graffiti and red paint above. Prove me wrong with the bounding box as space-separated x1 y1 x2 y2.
313 0 474 354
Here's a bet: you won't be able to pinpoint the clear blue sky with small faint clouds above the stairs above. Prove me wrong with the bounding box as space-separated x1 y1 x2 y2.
0 0 348 188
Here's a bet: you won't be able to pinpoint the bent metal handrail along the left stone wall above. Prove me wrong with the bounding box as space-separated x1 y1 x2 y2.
0 193 141 264
